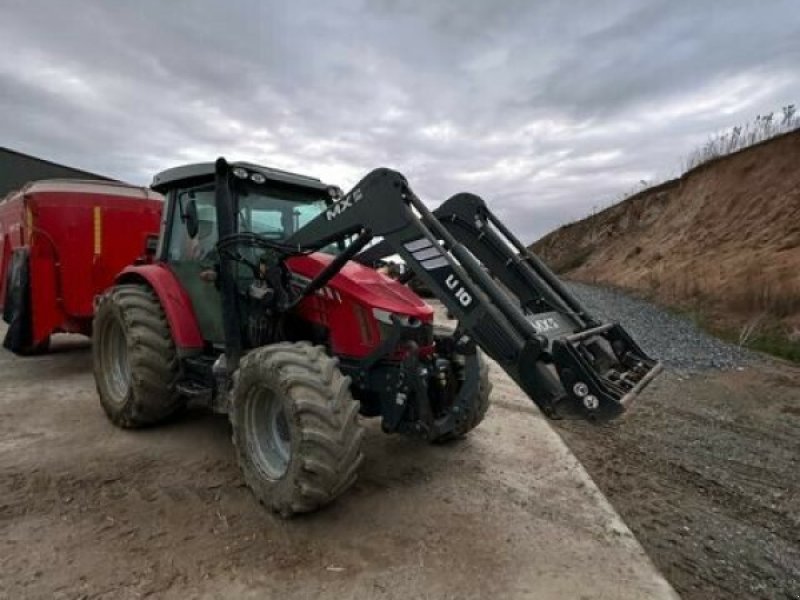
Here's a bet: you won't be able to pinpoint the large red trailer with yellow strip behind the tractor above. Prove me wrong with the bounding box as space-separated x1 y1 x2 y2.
0 179 163 354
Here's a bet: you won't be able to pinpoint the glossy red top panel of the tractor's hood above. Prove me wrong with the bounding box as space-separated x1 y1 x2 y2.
286 252 433 321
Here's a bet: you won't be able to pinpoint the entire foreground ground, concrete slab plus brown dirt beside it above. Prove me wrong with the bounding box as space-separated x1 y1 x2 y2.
6 300 800 600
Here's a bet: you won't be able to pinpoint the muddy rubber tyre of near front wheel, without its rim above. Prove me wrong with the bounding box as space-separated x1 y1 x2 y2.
230 342 364 517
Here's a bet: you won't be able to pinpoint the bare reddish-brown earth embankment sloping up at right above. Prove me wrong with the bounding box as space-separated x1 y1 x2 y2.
532 131 800 342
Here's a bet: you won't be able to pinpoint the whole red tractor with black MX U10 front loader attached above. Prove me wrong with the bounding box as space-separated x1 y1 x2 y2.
93 159 660 516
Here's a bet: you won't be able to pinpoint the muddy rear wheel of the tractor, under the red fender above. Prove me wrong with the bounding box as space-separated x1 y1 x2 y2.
92 284 185 428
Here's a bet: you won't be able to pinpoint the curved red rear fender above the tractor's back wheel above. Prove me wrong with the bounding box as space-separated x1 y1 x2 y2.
115 264 204 356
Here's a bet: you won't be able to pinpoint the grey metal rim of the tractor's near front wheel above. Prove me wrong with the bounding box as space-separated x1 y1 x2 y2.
248 386 292 479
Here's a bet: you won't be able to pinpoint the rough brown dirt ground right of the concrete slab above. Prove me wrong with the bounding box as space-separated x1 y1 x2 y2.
556 362 800 600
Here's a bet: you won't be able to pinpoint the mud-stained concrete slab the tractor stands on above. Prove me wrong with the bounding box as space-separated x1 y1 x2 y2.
0 328 674 600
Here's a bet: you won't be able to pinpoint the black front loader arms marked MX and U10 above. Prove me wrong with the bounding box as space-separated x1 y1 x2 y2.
285 169 660 418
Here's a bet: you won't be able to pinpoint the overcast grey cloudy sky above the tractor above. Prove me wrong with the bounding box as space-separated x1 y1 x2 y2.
0 0 800 241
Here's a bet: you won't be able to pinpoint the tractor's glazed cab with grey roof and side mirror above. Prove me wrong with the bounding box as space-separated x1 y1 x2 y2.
151 163 339 348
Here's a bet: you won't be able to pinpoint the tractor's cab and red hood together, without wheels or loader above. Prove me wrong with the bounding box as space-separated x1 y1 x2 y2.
152 163 433 365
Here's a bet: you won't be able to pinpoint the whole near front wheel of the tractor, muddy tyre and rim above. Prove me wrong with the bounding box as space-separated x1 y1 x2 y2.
230 342 364 517
